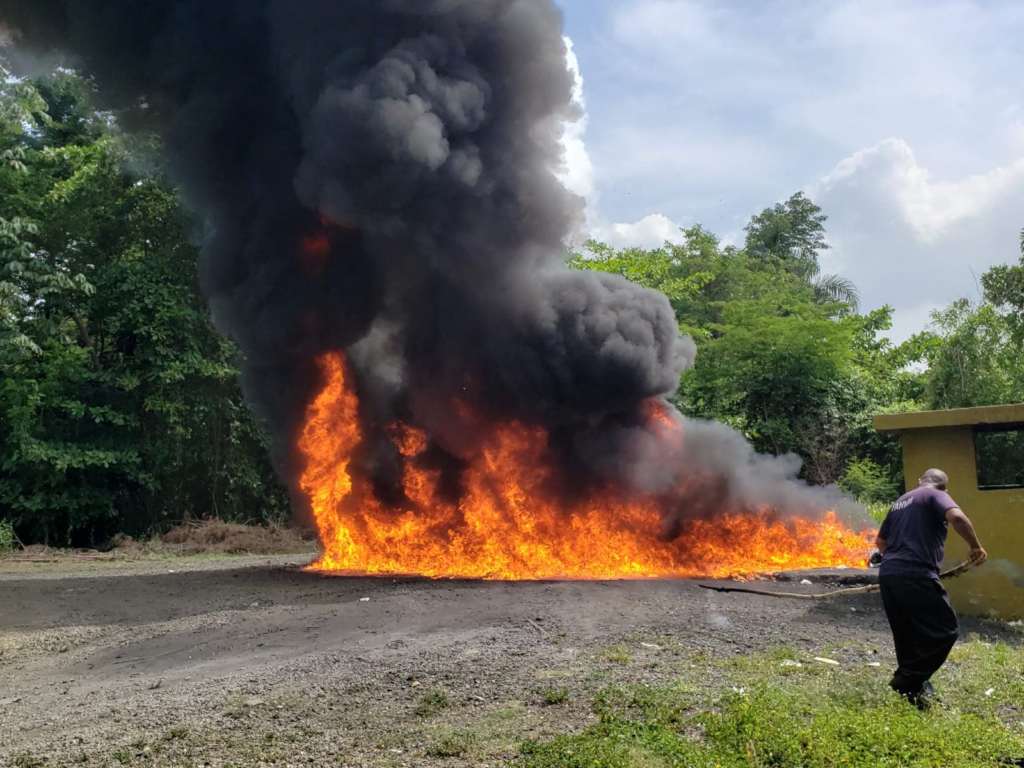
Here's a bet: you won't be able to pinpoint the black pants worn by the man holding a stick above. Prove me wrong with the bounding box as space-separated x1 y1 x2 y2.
879 575 959 696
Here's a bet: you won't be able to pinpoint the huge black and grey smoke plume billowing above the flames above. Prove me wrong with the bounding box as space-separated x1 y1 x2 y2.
0 0 864 518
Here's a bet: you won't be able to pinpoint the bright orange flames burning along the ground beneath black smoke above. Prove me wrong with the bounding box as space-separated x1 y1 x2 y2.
298 353 872 580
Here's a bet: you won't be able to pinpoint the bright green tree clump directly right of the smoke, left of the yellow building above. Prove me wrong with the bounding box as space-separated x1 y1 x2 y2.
570 208 924 483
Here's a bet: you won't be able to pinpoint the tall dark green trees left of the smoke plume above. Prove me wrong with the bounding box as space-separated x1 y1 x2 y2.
0 67 287 545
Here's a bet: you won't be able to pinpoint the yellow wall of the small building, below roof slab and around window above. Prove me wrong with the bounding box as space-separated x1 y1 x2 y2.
900 426 1024 620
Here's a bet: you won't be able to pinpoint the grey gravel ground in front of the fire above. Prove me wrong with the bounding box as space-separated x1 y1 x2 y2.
0 557 1020 766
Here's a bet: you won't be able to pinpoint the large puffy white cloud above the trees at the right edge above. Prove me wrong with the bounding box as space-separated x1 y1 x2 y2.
808 139 1024 339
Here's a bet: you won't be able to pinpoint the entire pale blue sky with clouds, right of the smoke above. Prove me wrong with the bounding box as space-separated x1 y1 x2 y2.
559 0 1024 338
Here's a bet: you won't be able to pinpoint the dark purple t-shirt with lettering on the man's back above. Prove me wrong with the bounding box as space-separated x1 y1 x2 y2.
879 486 957 577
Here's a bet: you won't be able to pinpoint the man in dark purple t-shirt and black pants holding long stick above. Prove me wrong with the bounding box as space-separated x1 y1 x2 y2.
876 469 988 709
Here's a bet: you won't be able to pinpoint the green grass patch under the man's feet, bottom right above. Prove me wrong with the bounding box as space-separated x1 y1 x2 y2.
520 642 1024 768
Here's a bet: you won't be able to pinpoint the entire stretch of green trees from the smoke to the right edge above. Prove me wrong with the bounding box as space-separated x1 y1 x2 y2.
569 193 1024 493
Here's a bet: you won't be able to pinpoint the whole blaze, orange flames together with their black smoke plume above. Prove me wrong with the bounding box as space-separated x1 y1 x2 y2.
0 0 867 579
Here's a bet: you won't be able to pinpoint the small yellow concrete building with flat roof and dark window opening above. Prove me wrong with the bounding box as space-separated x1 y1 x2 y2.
874 404 1024 620
